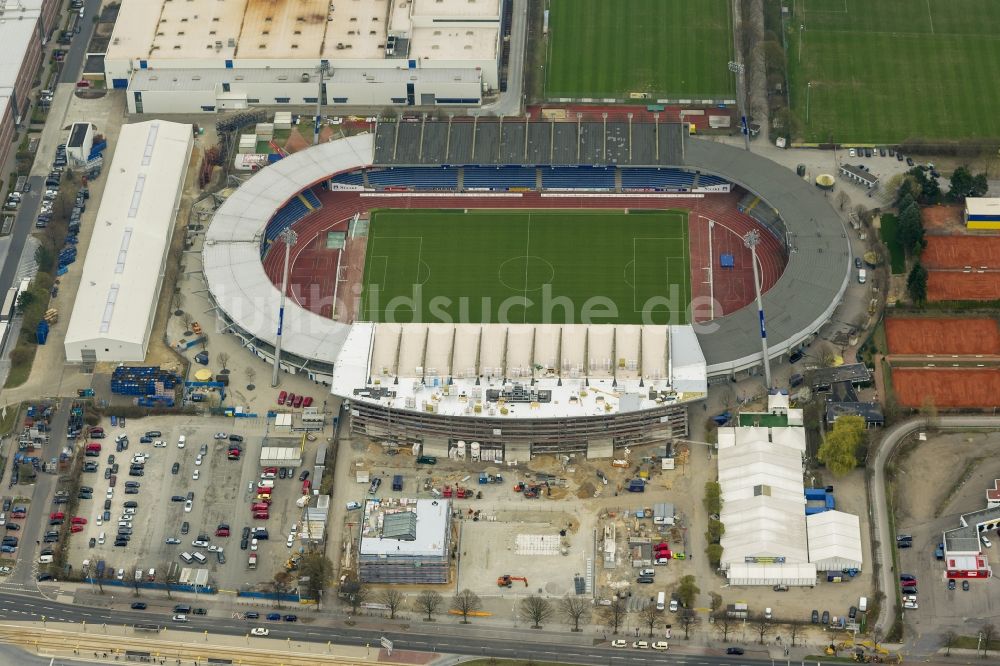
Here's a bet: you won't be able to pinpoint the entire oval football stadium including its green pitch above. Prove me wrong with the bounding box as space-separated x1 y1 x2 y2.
203 118 851 460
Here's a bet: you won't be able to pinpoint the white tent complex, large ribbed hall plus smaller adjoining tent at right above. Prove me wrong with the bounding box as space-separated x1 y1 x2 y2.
718 393 863 586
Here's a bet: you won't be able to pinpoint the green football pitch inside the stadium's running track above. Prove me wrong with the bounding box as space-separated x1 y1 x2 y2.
359 210 691 324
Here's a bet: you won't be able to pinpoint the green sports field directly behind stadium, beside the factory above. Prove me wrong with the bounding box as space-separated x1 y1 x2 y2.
544 0 735 99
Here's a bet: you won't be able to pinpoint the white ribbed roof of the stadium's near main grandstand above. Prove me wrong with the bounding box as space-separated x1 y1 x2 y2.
332 323 708 418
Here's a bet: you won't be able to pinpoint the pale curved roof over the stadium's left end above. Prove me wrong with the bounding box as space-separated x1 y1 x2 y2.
203 134 374 363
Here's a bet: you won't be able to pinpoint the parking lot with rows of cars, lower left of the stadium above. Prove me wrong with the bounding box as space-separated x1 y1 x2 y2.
67 417 315 591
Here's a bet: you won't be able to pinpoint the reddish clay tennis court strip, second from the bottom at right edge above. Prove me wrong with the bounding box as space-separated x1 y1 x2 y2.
885 317 1000 354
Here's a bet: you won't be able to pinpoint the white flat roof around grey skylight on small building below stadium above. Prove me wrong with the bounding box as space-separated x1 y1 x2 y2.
360 499 451 557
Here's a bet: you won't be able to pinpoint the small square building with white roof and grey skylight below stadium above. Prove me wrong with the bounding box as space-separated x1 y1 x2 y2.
358 499 451 584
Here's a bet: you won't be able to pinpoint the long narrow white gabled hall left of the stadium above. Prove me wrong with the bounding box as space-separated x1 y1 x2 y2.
65 121 193 364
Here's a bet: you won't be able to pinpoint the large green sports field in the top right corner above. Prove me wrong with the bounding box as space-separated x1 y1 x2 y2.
788 0 1000 143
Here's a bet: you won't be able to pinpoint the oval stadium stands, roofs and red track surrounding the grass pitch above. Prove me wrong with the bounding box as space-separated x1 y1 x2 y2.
204 119 850 459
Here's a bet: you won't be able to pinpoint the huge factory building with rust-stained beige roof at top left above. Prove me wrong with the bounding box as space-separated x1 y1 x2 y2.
104 0 505 113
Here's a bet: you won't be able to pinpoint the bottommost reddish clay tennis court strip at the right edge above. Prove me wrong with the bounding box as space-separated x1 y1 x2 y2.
892 368 1000 409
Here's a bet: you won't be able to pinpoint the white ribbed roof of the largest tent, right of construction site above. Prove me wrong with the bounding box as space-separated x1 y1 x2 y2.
719 428 809 566
